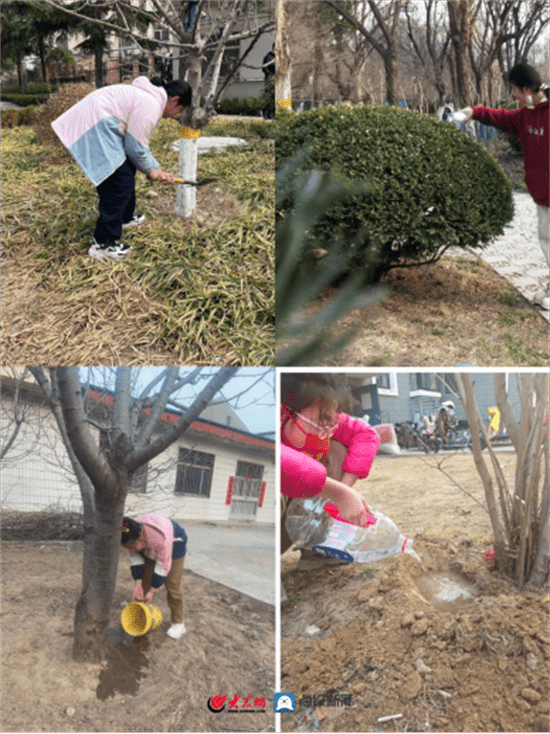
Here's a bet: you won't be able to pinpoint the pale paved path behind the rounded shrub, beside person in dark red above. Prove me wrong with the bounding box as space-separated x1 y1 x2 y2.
452 191 550 321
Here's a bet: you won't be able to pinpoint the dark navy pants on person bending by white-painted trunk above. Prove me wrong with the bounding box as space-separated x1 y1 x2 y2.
94 158 136 245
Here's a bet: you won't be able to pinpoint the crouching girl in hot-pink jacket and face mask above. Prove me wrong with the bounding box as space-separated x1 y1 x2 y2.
281 373 380 564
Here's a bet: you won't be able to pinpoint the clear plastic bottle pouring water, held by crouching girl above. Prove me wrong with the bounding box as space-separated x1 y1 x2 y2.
285 497 420 563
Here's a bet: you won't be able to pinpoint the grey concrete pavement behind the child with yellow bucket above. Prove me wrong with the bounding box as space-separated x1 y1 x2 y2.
174 518 275 605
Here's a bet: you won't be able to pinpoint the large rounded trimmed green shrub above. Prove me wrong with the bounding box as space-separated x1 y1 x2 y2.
276 105 514 281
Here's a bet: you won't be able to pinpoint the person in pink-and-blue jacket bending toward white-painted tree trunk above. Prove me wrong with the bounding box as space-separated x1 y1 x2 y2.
52 76 192 260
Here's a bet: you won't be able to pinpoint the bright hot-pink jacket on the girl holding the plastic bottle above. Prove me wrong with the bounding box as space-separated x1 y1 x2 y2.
281 413 380 497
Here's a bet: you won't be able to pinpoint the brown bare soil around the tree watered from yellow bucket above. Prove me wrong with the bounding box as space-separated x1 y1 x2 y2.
2 541 275 732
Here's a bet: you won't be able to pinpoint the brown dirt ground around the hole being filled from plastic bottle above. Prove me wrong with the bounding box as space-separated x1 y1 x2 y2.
281 453 549 732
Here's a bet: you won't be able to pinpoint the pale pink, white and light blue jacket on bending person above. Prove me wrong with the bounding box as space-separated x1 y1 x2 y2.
52 76 168 186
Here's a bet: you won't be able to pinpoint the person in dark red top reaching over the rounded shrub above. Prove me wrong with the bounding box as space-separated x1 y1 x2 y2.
459 64 550 311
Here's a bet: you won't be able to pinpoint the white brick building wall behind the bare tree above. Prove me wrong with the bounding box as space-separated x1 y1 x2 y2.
0 396 275 524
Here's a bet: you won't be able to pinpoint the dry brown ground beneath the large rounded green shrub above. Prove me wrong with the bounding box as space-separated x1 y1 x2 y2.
314 256 549 367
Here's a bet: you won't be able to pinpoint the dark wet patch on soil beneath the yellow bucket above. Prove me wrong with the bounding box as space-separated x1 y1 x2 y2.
96 629 149 701
